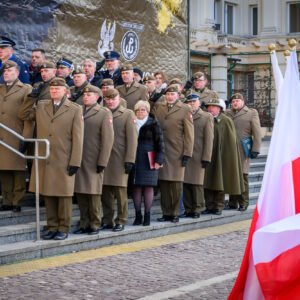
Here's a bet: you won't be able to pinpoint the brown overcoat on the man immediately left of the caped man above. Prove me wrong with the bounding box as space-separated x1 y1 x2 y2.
184 108 214 185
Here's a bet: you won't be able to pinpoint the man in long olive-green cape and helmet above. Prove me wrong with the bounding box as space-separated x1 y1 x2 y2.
202 99 244 215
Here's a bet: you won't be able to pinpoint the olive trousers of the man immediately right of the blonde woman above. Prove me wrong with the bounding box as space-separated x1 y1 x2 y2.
159 180 182 217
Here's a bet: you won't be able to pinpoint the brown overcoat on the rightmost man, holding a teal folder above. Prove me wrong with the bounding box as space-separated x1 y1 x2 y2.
226 106 262 174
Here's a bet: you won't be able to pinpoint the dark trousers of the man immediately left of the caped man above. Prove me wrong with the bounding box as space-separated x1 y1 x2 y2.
183 183 205 214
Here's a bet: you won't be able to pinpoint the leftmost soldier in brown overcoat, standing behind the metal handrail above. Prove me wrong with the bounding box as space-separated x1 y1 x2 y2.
0 60 33 212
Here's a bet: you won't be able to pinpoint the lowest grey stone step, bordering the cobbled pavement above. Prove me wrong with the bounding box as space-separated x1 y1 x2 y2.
0 206 254 265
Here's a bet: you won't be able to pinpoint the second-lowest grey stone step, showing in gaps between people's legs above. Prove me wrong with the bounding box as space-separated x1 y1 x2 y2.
0 193 258 245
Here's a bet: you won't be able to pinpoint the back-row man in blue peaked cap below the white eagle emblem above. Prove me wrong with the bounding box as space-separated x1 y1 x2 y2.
101 51 124 86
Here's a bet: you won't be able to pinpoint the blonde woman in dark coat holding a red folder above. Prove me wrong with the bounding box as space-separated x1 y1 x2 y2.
133 100 164 226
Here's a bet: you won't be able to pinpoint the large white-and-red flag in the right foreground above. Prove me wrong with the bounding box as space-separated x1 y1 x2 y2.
228 52 300 300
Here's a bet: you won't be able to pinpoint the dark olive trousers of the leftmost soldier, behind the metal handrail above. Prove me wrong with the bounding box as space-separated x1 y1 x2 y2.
0 171 26 206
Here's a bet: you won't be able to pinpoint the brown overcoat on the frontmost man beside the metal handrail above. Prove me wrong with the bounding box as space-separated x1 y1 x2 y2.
19 98 84 197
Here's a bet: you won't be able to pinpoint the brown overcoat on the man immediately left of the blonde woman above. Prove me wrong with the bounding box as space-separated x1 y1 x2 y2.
103 105 137 187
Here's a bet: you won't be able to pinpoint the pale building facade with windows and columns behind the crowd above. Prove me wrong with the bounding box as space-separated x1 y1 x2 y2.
190 0 300 127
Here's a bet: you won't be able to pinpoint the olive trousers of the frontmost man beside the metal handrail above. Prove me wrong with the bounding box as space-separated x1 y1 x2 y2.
44 196 72 233
